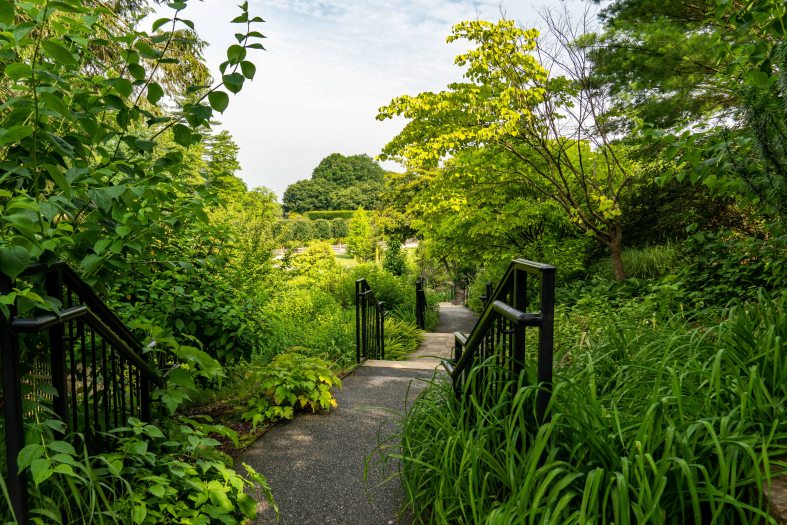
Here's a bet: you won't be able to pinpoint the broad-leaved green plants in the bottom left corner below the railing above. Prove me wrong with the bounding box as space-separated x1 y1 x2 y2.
0 417 278 525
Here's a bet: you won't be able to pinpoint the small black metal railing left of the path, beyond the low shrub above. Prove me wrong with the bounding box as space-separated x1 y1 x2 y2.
355 279 386 363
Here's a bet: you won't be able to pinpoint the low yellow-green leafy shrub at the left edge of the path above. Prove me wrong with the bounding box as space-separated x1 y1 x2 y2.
243 353 342 427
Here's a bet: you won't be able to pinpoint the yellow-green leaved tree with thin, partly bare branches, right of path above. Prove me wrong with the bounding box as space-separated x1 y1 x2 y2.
378 20 638 280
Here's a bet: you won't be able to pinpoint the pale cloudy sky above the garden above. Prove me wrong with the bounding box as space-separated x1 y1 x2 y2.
155 0 584 196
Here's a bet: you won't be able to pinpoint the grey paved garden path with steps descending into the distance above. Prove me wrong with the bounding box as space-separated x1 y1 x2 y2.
243 303 476 525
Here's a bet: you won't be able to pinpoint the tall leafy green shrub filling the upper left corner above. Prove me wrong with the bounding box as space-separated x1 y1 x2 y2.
0 0 263 306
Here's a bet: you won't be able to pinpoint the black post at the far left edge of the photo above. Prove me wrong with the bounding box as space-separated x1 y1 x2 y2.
0 274 27 524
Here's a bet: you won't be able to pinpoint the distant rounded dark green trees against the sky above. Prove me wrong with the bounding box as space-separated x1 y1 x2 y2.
282 153 385 213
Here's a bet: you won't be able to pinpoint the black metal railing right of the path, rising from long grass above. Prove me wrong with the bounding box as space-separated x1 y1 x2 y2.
444 259 555 423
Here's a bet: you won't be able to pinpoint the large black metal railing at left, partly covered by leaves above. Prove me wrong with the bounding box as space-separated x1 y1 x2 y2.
0 263 164 523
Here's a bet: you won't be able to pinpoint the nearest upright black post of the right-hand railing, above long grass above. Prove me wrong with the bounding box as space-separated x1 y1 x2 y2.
536 268 555 423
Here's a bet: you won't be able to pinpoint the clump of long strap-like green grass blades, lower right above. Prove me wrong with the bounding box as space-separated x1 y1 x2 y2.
396 296 787 524
